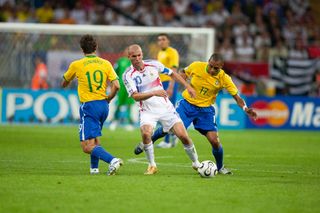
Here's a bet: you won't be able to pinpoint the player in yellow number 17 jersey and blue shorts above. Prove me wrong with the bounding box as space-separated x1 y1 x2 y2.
135 53 257 174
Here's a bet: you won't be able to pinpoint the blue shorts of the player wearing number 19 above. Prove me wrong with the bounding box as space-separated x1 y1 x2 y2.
79 100 109 141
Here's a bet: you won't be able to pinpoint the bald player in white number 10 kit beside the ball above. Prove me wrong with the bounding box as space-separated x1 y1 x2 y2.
123 44 200 175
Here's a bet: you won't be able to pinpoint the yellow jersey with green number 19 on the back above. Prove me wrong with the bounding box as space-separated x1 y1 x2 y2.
63 55 118 102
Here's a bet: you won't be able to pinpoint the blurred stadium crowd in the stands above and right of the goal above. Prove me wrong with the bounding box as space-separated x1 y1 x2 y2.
0 0 320 95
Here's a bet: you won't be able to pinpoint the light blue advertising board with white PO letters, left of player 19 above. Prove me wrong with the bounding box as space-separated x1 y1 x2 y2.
1 89 80 123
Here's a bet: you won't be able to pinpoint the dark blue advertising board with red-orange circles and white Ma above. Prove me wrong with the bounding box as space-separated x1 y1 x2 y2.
246 96 320 130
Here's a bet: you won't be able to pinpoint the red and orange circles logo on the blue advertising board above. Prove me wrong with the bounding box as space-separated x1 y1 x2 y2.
251 100 289 127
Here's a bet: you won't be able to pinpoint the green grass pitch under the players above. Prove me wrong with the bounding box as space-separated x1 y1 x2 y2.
0 126 320 213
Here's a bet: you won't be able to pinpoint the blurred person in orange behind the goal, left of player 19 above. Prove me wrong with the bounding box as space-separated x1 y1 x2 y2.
31 57 49 90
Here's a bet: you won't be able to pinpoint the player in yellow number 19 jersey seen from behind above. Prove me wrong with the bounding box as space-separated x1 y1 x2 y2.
62 35 123 175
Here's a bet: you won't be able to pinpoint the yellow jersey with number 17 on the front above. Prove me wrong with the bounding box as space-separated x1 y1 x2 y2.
182 61 238 107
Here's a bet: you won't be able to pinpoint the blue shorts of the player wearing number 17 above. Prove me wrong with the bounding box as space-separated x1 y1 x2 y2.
176 99 218 135
